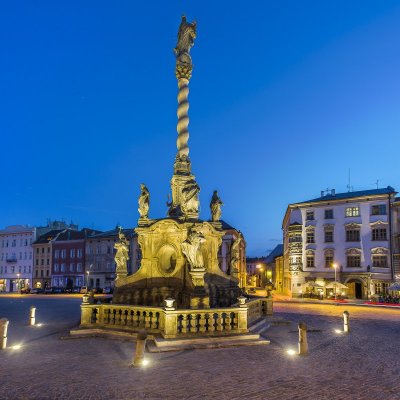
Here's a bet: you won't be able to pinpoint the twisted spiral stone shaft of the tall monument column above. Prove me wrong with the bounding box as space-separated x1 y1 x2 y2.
176 78 189 157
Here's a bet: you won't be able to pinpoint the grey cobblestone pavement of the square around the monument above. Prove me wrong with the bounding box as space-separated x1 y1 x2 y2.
0 298 400 400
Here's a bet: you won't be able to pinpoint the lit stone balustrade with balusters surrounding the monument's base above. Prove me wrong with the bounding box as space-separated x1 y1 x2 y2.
81 298 272 338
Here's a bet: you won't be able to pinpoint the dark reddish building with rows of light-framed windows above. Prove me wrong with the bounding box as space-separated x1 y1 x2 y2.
51 228 100 289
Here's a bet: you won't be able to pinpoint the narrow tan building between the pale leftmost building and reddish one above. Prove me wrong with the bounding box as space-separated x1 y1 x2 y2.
32 230 62 289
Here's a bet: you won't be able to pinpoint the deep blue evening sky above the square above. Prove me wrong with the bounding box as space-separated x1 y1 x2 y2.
0 0 400 255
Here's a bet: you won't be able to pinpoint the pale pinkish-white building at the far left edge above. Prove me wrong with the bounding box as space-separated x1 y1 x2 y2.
0 225 36 292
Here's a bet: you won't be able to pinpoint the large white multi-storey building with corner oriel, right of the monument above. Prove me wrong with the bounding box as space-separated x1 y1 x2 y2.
282 186 396 299
